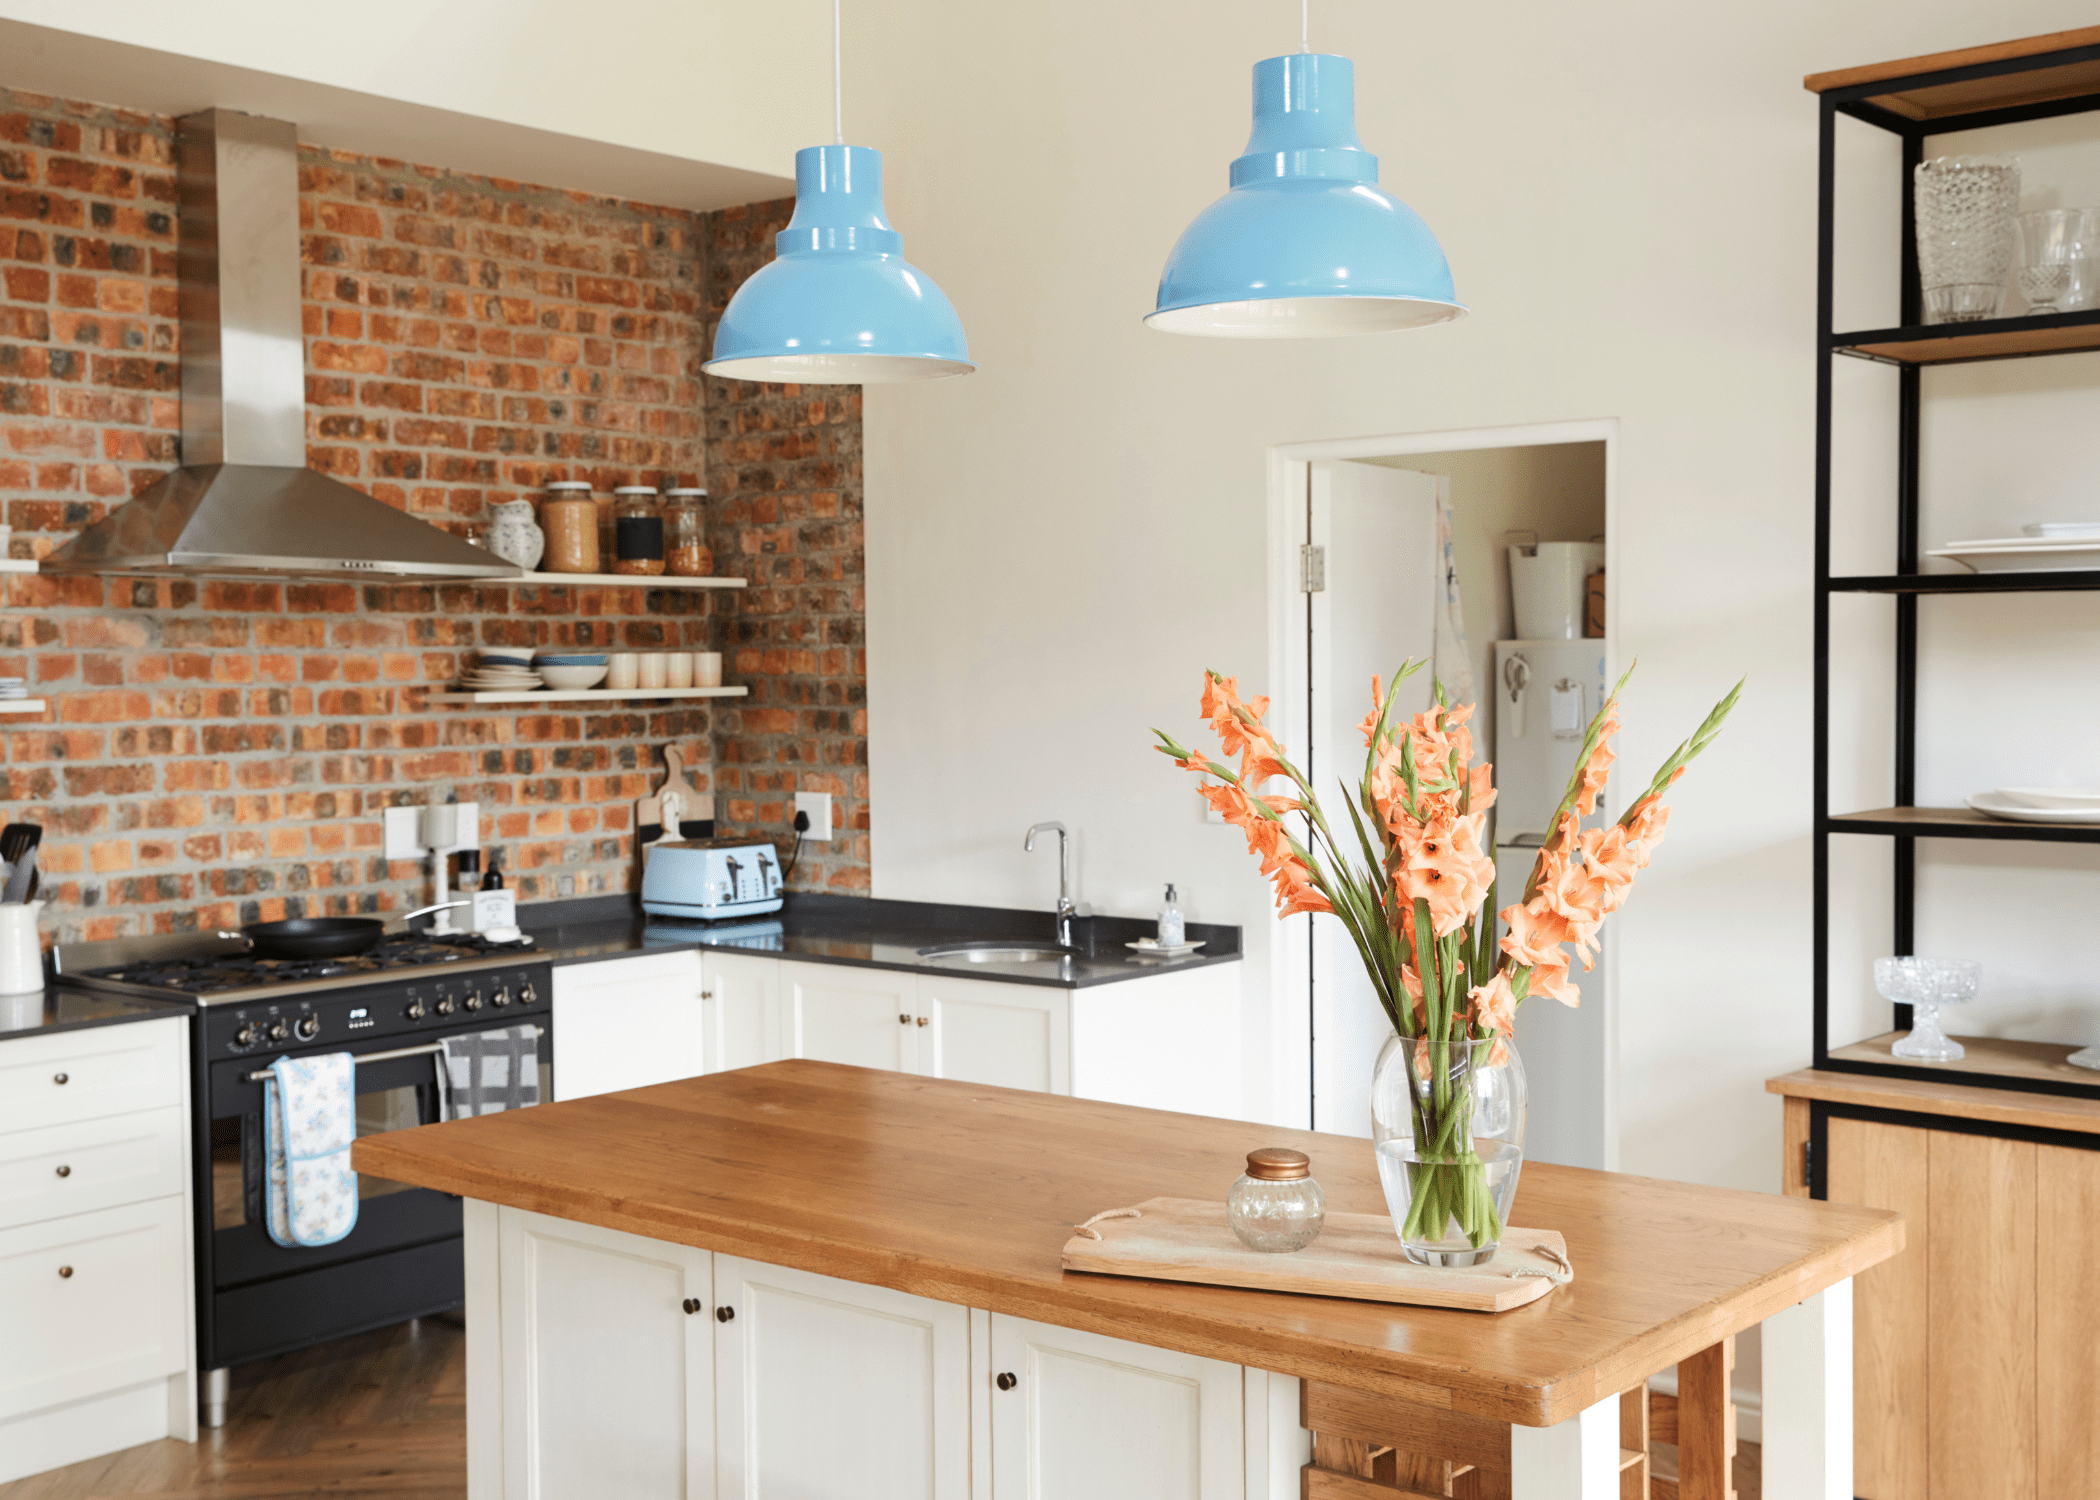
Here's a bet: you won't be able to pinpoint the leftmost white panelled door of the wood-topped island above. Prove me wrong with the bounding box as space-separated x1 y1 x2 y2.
498 1201 714 1500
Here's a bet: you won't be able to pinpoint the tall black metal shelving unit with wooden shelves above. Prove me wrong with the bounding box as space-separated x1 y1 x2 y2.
1808 32 2100 1097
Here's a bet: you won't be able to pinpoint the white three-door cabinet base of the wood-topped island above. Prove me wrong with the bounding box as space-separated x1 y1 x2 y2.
466 1202 1268 1500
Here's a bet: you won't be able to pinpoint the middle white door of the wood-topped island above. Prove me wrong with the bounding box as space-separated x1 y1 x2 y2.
709 1254 970 1500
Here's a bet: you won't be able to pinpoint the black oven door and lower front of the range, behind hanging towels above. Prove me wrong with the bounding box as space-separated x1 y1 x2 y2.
200 1017 552 1368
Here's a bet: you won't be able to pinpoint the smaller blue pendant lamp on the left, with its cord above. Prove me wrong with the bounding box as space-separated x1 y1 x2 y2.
701 0 977 384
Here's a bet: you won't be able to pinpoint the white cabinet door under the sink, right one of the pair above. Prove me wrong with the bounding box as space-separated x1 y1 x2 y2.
916 975 1071 1095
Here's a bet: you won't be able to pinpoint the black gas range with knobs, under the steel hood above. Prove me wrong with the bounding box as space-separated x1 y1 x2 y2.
57 933 554 1424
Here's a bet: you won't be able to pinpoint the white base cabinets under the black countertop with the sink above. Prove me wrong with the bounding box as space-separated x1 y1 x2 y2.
554 947 1241 1118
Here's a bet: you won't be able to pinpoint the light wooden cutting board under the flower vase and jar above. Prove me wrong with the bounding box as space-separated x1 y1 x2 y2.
1065 1197 1573 1313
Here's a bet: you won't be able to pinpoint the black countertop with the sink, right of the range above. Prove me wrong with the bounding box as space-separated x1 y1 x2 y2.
519 895 1241 989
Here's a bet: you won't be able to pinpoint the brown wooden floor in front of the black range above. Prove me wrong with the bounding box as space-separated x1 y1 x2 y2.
0 1317 466 1500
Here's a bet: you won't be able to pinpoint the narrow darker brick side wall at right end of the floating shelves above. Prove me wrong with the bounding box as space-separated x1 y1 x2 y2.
706 200 869 895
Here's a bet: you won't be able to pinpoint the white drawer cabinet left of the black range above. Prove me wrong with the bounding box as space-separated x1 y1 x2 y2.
0 1015 197 1483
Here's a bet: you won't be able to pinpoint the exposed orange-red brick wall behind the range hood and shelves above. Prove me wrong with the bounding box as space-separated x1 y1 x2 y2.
0 90 867 939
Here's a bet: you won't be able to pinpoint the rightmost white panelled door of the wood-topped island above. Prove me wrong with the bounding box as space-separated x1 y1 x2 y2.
985 1313 1247 1500
